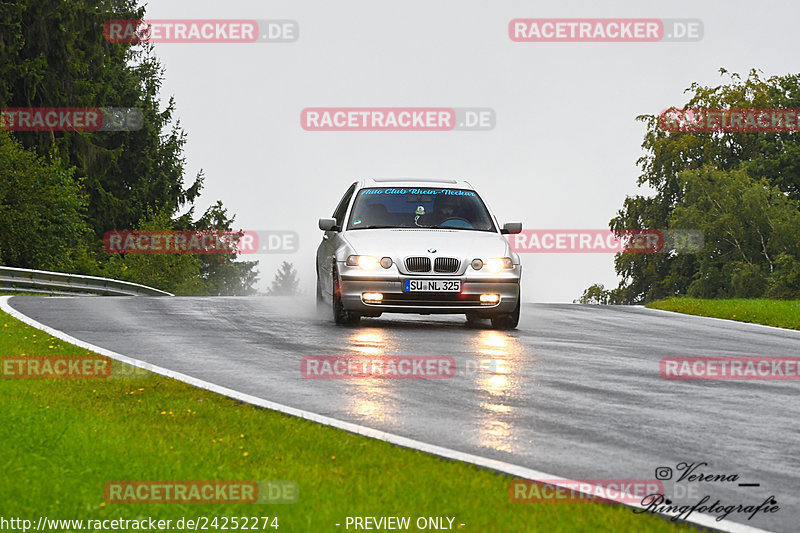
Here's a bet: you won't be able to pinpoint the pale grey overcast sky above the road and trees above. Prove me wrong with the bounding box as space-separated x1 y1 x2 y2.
139 0 800 302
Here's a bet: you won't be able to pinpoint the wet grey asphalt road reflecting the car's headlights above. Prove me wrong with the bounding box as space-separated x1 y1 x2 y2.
11 297 800 532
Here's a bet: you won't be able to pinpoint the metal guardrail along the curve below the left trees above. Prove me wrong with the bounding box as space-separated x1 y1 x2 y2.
0 266 174 296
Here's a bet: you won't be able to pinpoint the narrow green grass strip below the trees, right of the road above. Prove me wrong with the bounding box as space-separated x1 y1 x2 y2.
647 298 800 329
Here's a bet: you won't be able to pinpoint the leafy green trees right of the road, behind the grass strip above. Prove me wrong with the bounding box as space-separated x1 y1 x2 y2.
580 69 800 304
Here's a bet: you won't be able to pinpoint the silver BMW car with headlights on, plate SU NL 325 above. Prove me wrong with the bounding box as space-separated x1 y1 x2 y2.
316 179 522 329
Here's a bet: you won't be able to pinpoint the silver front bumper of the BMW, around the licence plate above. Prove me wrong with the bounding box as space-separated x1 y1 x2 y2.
339 274 520 317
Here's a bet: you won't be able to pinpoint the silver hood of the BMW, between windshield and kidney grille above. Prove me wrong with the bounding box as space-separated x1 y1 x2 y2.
344 228 510 261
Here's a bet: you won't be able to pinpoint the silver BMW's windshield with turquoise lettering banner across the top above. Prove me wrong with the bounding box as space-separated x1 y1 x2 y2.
347 187 495 231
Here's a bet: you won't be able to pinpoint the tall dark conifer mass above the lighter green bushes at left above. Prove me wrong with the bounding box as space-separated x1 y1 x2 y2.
0 0 202 237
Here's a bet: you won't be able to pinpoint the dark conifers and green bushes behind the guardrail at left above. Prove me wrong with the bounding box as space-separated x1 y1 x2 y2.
0 0 257 295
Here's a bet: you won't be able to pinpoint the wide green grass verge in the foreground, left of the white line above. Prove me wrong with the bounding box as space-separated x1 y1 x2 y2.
0 306 697 532
